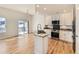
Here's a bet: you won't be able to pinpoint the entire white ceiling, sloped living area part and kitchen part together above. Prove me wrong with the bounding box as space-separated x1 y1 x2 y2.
0 4 73 14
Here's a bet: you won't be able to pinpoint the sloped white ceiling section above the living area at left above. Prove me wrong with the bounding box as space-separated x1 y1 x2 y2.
0 4 35 14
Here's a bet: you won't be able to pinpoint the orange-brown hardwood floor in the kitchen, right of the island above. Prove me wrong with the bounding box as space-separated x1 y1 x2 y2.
48 39 73 54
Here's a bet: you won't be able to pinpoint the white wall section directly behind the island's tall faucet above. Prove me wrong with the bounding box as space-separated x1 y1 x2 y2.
33 13 45 32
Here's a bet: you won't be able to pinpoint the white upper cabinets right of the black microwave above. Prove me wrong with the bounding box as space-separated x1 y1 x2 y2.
60 12 73 25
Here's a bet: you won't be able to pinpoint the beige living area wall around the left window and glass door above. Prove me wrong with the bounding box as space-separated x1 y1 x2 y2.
0 8 31 39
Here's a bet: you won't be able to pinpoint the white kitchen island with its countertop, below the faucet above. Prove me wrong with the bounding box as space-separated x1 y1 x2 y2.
34 33 48 54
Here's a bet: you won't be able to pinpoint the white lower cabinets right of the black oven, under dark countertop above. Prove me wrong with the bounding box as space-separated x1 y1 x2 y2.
60 30 73 42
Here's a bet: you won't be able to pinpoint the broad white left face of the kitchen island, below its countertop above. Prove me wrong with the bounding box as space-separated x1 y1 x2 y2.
34 36 43 54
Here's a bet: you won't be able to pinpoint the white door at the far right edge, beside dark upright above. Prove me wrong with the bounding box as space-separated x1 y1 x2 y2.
76 5 79 53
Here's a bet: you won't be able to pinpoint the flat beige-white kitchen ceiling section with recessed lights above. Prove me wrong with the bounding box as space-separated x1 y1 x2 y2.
36 4 73 14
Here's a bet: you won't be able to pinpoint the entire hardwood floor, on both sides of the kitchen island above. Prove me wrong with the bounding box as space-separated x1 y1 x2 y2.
0 34 73 54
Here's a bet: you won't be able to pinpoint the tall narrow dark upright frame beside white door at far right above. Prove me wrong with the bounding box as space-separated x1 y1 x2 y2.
72 4 76 53
